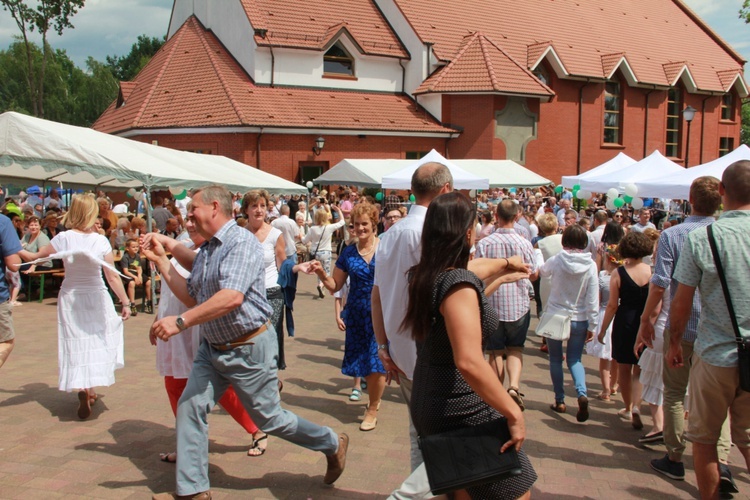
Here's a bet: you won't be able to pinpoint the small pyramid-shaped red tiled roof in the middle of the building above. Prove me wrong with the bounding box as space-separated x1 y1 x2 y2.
414 33 554 97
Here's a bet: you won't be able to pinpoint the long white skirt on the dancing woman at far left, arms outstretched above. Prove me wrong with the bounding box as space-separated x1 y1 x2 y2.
57 288 125 392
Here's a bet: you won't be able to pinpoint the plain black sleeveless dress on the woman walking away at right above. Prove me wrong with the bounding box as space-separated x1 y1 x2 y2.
612 266 648 365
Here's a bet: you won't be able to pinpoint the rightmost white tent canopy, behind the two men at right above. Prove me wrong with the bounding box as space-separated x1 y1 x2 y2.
635 144 750 200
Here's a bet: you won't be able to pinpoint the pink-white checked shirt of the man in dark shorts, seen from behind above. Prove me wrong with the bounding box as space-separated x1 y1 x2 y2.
476 228 536 322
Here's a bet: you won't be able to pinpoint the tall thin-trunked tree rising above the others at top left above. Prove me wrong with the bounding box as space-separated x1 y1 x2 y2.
0 0 85 118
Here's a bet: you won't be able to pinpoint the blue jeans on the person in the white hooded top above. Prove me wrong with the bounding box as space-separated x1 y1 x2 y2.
547 321 589 403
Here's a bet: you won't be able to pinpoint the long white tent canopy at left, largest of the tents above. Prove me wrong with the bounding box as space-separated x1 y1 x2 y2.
0 112 306 193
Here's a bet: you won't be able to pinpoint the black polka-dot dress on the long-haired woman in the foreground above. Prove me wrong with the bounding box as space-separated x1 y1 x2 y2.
411 269 537 499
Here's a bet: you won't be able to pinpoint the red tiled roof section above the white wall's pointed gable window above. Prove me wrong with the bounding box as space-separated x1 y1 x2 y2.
241 0 409 59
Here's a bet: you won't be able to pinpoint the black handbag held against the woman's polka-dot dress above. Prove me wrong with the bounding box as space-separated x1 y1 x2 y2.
419 418 522 496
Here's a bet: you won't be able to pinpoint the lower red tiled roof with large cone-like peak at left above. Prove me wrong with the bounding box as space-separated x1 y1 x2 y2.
93 17 452 133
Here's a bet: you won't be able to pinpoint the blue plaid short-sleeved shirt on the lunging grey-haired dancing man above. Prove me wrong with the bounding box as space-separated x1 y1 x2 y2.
187 220 273 344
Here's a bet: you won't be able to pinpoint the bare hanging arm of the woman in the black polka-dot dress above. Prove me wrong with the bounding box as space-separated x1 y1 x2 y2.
440 284 526 452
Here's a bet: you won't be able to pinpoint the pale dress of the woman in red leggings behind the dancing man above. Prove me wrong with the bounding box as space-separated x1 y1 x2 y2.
156 246 200 378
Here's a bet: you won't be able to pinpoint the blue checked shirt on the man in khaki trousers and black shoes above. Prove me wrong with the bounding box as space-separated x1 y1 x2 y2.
651 216 714 342
